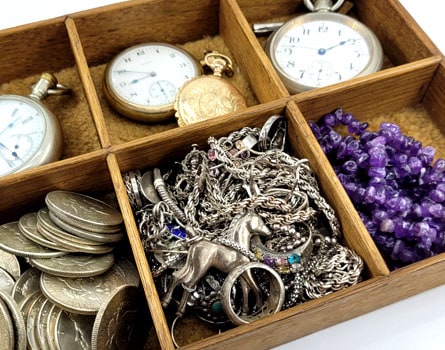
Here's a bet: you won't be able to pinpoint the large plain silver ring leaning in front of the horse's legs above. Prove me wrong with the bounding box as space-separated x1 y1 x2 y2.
221 262 285 325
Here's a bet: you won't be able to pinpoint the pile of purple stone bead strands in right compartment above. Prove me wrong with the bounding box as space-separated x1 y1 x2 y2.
309 109 445 269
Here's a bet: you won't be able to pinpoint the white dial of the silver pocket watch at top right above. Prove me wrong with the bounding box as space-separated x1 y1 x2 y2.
276 21 370 87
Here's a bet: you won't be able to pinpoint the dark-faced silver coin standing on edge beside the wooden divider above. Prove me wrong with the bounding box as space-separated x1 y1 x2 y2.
91 285 150 350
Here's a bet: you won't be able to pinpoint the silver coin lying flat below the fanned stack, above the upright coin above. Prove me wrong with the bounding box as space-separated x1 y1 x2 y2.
40 260 138 315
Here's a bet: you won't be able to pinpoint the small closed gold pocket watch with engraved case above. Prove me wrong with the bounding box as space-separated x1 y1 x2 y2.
174 51 247 126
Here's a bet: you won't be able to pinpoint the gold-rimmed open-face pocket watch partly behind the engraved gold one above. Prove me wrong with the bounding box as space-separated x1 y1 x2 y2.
103 43 202 122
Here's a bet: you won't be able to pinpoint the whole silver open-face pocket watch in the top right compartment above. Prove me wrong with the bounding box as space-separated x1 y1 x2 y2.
265 0 383 93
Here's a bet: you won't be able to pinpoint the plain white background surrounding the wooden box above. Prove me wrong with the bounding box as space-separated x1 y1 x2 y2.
0 0 445 350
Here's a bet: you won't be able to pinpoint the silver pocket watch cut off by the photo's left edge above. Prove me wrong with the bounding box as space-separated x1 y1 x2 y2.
0 73 71 176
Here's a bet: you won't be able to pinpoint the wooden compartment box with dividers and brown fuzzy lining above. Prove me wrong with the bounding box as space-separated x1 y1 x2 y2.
0 0 445 349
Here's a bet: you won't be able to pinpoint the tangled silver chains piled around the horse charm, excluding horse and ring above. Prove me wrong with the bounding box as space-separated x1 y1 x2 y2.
124 118 363 322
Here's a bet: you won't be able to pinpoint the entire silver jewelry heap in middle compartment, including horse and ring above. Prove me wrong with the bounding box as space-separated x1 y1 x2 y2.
123 115 363 325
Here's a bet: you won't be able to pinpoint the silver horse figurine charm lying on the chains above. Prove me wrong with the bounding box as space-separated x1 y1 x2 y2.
162 211 272 316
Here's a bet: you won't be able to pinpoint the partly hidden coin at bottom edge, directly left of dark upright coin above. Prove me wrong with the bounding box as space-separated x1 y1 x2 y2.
56 311 95 350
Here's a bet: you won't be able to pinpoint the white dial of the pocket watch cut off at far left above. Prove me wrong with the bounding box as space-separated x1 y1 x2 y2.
0 96 47 176
